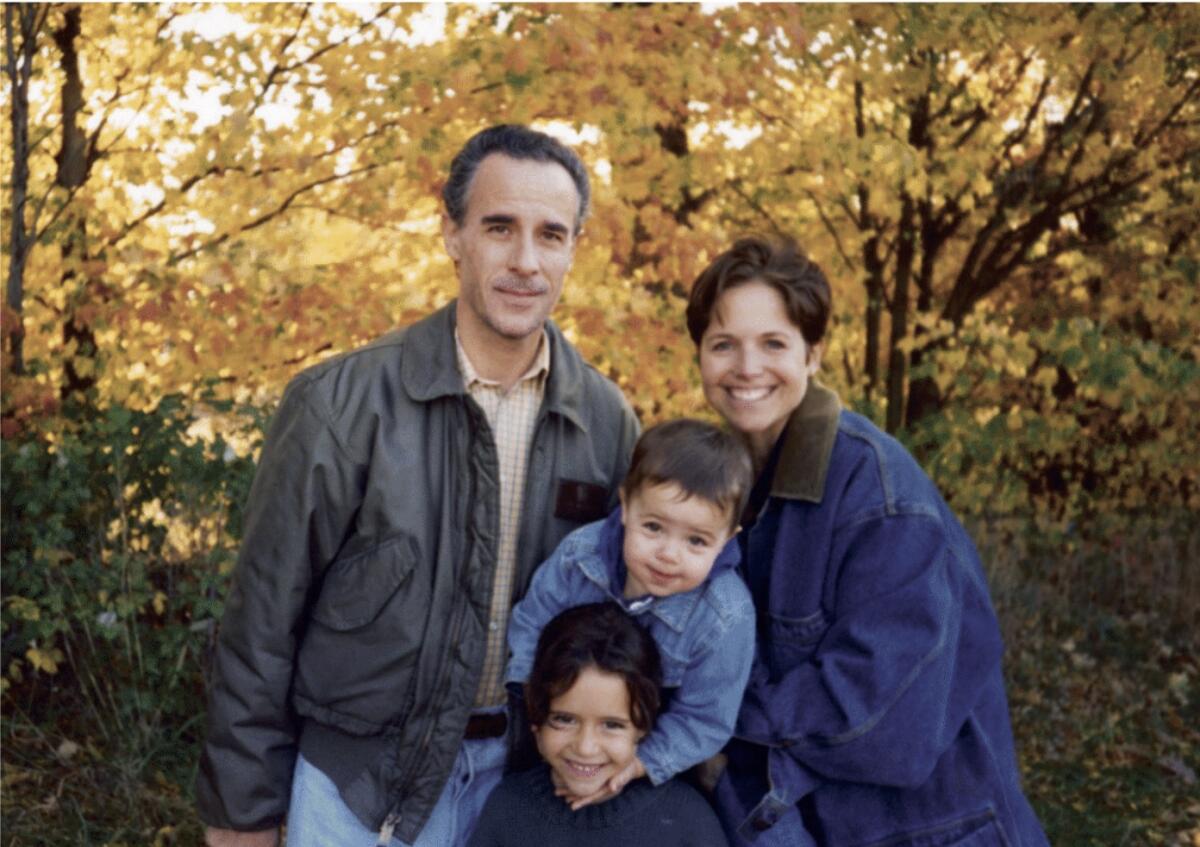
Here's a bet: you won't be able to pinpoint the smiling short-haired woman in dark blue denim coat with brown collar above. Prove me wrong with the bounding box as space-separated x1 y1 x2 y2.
688 239 1046 847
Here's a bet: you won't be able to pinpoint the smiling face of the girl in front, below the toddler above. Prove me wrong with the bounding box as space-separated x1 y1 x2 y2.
533 667 644 797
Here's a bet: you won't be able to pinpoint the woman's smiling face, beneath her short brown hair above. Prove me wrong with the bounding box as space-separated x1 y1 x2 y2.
700 281 821 459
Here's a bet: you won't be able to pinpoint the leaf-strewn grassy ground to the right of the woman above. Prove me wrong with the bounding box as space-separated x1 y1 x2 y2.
977 513 1200 847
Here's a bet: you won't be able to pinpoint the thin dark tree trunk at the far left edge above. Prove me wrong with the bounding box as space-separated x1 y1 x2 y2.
4 4 41 376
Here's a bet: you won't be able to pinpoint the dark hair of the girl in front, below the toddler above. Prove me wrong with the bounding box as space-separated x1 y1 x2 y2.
526 602 662 732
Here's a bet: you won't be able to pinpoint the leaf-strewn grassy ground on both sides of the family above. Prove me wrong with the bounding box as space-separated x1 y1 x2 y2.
0 518 1200 847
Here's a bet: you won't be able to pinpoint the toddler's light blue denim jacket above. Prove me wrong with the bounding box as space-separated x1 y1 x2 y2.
504 509 755 785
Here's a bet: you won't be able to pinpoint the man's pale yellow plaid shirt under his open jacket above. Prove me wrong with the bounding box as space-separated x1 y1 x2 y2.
455 330 550 708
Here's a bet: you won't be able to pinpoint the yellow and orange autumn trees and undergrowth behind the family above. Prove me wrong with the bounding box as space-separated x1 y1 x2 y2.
0 4 1200 845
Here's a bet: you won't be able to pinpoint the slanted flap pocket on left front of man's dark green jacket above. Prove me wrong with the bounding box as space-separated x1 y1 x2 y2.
312 535 416 631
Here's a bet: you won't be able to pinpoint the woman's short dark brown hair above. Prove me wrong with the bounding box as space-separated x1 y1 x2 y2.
688 236 833 347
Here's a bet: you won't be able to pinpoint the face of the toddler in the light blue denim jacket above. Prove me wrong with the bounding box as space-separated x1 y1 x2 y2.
620 482 734 597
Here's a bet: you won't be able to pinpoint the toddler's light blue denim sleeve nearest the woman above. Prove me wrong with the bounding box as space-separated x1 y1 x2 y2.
637 572 755 785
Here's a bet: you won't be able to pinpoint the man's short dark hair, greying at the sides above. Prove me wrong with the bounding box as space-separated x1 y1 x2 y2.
442 124 592 235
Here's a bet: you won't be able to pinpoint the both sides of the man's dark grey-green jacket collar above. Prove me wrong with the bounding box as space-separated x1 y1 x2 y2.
401 300 586 429
